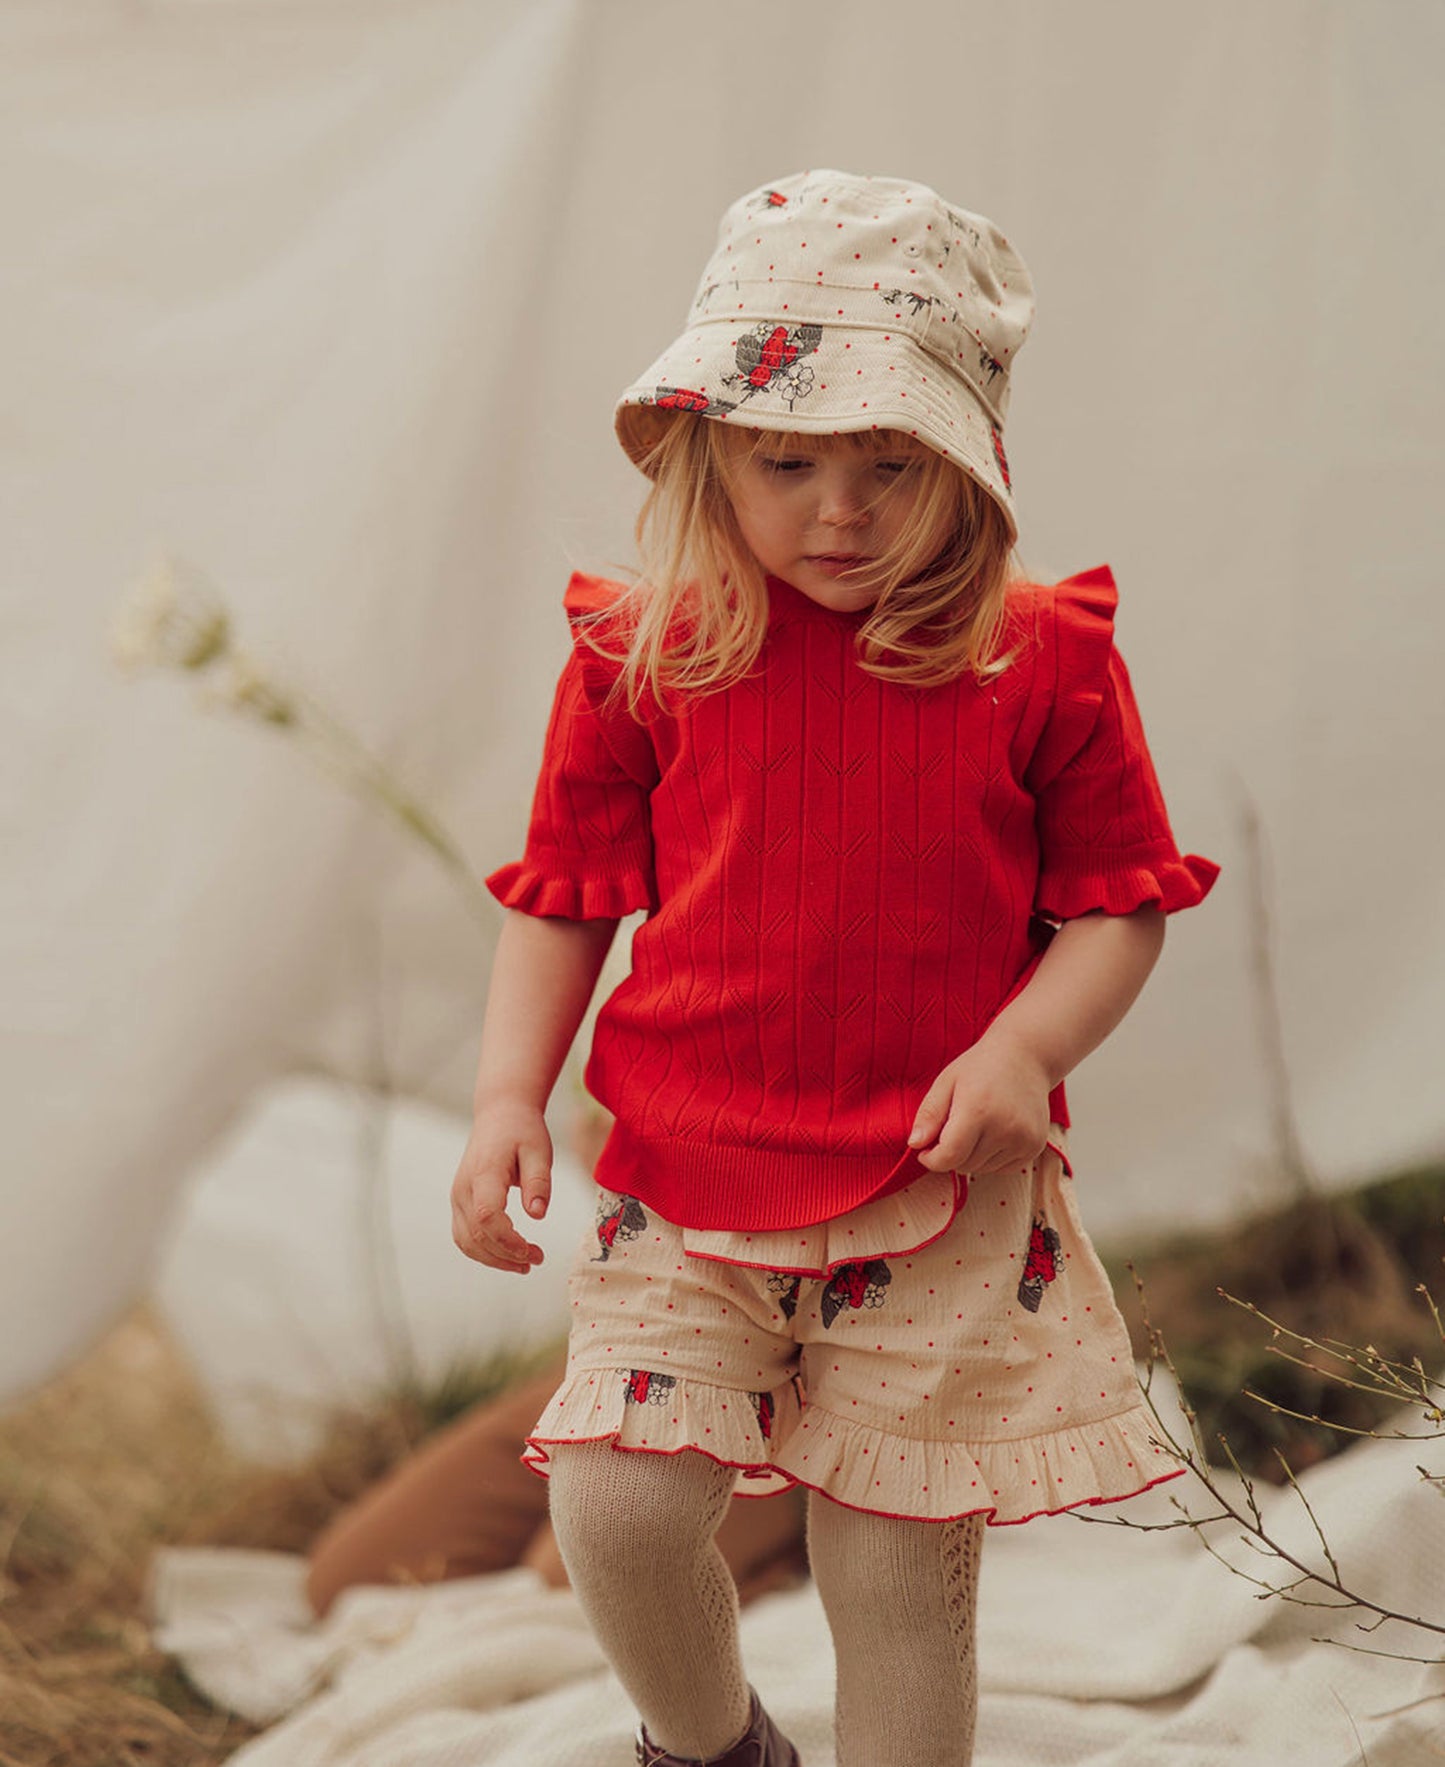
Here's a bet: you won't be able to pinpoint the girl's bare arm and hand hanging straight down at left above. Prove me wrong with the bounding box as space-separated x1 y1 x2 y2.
452 910 617 1276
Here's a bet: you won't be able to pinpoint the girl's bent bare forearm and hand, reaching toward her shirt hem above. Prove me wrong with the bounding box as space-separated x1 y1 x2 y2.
908 906 1164 1177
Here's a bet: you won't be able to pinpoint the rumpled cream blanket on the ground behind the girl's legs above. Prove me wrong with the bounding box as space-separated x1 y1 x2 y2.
152 1420 1445 1767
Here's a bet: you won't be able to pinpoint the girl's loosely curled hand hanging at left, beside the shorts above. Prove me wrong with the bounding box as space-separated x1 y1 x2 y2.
452 1099 551 1276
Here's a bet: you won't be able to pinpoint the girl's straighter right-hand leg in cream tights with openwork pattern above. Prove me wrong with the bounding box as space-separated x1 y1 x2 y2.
807 1491 984 1767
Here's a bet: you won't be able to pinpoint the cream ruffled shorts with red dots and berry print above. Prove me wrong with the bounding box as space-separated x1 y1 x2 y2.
523 1133 1182 1525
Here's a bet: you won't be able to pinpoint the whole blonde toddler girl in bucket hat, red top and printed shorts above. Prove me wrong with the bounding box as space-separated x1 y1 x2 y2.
452 171 1215 1767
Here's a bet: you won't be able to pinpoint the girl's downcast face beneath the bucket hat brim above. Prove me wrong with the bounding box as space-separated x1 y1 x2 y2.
723 424 949 613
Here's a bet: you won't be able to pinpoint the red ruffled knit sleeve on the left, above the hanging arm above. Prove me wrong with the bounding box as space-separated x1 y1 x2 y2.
486 576 657 921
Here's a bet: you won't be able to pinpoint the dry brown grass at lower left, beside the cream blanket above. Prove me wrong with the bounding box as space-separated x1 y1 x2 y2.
0 1308 540 1767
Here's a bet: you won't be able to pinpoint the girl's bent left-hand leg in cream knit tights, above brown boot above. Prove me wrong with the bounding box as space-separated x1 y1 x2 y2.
549 1442 748 1767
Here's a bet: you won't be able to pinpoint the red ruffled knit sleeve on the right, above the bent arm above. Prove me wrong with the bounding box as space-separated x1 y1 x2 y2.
1026 565 1219 921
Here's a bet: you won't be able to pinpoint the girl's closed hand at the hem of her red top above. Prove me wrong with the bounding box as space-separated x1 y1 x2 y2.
908 1032 1049 1177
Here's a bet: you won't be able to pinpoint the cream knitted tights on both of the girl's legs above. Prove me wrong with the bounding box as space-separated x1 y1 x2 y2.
551 1442 984 1767
